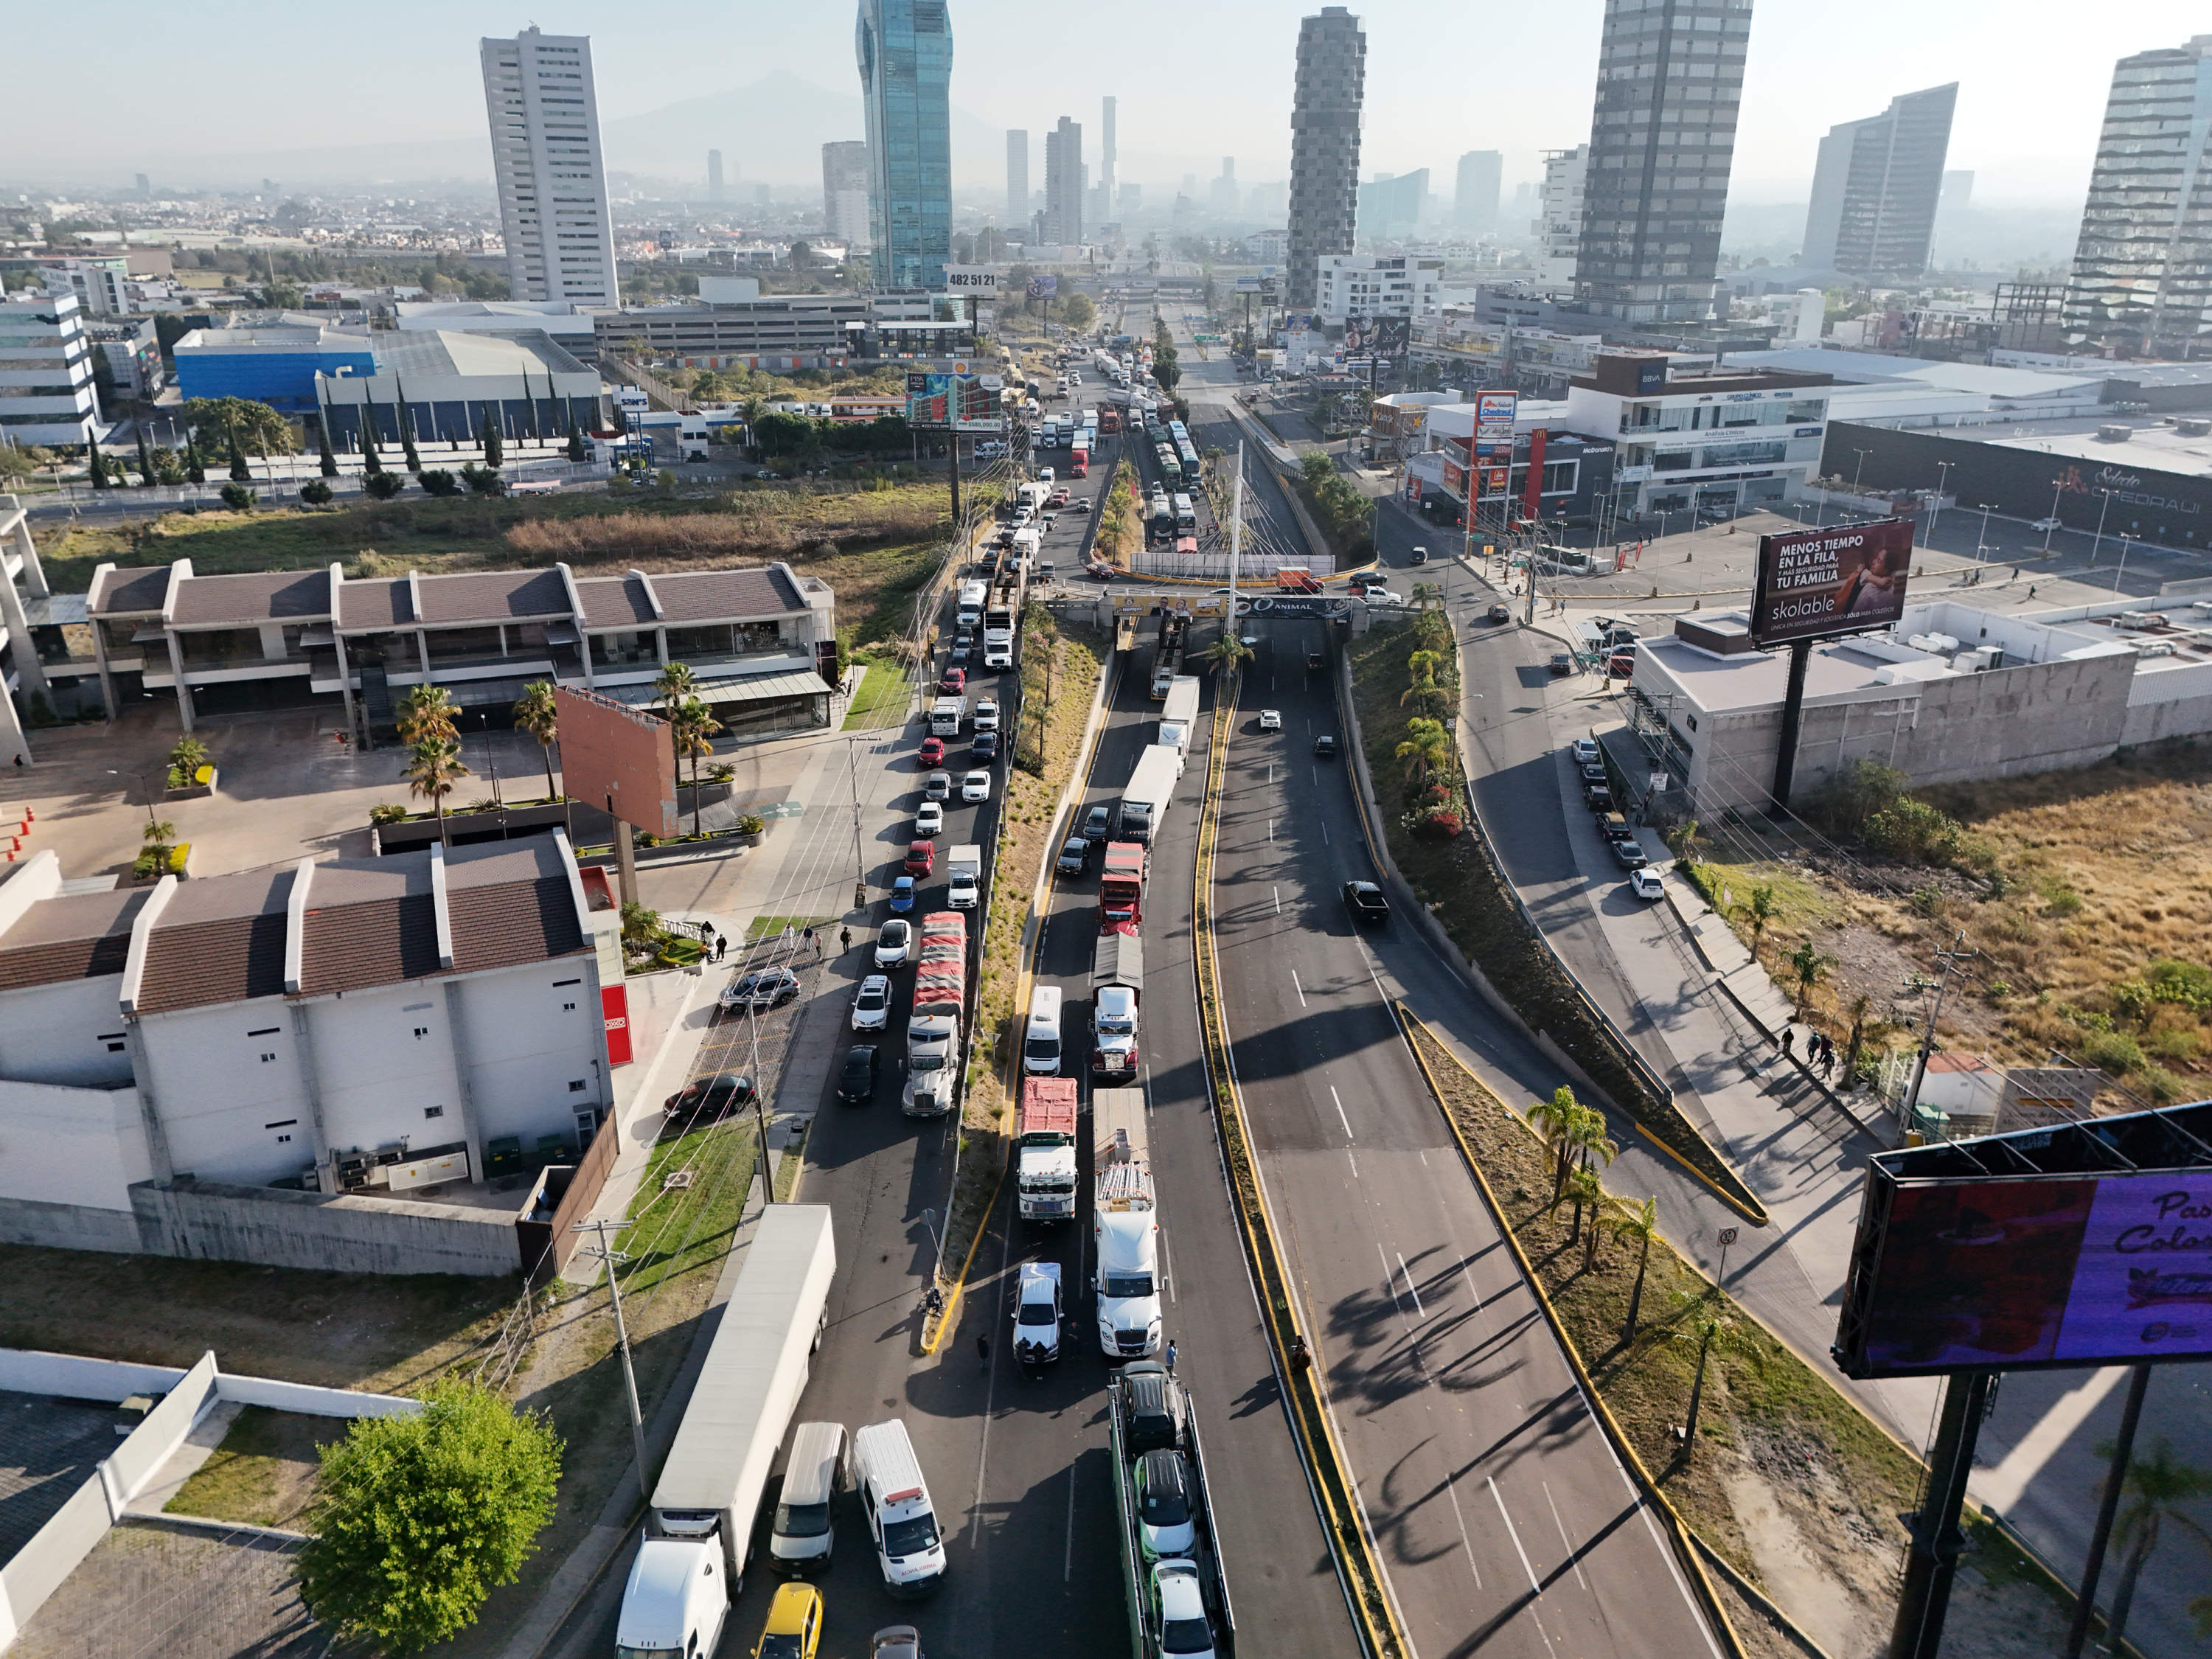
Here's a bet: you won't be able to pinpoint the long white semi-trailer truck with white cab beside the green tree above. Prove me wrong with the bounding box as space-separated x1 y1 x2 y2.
615 1203 836 1655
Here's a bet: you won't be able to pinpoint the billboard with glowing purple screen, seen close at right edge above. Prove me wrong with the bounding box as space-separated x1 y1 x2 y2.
1836 1168 2212 1378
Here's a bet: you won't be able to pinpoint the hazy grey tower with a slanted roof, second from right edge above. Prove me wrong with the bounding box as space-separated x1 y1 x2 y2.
1801 82 1958 276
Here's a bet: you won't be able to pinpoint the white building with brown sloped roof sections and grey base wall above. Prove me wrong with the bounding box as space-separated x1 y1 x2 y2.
0 832 624 1274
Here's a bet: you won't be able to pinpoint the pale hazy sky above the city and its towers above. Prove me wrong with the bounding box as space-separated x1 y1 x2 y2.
13 0 2212 206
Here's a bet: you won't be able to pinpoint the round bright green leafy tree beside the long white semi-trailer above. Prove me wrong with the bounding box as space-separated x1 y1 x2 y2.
299 1380 562 1652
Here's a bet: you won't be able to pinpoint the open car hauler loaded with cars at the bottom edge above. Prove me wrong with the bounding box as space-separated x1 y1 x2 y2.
1106 1360 1237 1659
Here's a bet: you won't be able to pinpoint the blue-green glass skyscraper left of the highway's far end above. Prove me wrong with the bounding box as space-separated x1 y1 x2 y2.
854 0 953 288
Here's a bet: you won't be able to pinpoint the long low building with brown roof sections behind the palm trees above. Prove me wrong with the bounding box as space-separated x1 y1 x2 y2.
86 560 836 739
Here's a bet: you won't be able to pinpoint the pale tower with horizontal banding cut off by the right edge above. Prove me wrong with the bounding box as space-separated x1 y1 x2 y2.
2064 35 2212 356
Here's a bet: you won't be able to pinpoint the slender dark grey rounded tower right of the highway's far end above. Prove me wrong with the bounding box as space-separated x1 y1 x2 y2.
1283 7 1367 312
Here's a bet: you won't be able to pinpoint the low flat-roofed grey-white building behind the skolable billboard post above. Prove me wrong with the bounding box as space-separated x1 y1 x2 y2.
1630 599 2212 818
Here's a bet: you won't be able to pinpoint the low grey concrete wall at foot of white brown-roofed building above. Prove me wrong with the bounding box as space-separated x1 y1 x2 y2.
131 1179 522 1279
